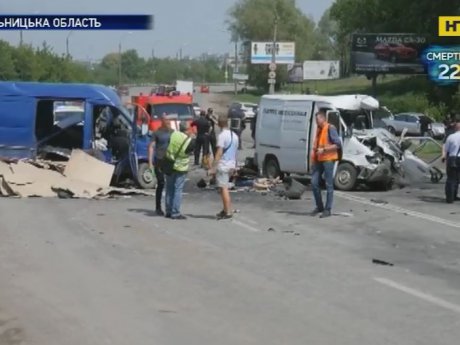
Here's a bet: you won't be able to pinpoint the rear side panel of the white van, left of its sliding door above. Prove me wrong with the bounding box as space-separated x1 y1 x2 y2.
256 98 284 168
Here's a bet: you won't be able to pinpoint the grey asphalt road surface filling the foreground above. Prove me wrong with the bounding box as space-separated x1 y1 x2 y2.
0 100 460 345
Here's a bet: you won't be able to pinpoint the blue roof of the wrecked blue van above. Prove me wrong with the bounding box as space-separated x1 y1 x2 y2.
0 82 121 106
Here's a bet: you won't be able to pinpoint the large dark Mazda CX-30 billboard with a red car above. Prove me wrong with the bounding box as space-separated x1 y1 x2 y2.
351 34 428 74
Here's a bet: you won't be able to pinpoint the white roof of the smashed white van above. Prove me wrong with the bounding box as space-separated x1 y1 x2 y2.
262 94 380 110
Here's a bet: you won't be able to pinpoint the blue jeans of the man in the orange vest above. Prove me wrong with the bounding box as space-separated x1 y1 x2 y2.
311 162 335 212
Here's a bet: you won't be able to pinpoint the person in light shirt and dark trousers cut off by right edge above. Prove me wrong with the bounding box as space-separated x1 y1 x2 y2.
443 118 460 204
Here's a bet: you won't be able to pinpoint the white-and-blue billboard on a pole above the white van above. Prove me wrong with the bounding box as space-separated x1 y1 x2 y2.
251 42 295 65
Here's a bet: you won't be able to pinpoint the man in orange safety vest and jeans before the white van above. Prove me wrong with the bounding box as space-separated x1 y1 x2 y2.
311 110 342 218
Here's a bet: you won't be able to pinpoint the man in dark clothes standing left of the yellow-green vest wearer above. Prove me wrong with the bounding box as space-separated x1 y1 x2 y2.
148 113 173 216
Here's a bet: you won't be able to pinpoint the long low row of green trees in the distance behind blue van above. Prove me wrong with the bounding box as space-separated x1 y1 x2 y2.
0 40 224 85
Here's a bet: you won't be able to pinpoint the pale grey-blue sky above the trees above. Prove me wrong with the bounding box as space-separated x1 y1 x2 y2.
0 0 334 61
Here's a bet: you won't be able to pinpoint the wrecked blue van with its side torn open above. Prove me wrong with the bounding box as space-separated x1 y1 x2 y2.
0 82 155 189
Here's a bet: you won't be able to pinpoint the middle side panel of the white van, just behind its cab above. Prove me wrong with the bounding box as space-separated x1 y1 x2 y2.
280 100 313 174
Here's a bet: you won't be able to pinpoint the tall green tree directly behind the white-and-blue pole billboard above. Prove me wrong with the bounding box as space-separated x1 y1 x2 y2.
228 0 316 88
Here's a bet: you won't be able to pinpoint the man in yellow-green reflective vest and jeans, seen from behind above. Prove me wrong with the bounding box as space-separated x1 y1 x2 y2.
166 121 194 220
